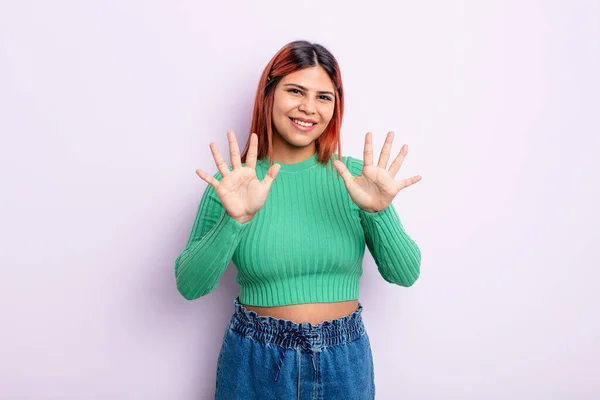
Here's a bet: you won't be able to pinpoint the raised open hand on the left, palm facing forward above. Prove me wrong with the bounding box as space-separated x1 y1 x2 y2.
196 131 280 224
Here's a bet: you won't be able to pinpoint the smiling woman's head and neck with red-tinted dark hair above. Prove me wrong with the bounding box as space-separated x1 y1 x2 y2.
241 41 344 165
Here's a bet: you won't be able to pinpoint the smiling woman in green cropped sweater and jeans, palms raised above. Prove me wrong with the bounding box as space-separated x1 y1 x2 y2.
175 41 421 400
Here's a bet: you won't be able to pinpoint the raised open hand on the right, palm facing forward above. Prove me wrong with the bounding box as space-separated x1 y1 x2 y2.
333 132 421 212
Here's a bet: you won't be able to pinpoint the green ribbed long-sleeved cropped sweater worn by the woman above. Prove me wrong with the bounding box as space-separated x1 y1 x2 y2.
175 153 421 306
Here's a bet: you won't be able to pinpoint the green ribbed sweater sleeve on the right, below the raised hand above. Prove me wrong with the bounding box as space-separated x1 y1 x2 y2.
348 157 421 287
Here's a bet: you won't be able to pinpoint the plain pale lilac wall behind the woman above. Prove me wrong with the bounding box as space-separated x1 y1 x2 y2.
0 0 600 400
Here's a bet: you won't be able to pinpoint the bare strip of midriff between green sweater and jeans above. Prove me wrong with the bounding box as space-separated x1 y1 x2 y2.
243 300 358 325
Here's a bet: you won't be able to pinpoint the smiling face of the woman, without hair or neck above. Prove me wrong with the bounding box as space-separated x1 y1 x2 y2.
273 66 335 152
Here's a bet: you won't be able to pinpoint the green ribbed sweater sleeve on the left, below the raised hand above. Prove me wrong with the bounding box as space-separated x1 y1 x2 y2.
175 168 254 300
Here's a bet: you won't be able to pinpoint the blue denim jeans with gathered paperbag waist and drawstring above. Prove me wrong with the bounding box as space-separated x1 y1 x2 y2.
215 298 375 400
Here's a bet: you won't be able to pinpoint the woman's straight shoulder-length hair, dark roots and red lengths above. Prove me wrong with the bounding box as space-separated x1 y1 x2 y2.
241 40 344 166
